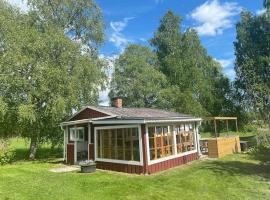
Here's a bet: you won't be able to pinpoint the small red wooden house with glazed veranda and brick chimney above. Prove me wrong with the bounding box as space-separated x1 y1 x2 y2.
61 98 201 174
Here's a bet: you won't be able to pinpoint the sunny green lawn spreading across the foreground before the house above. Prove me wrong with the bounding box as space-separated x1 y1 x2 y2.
0 138 270 200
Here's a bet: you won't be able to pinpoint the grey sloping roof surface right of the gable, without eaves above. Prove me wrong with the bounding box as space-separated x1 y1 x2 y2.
91 106 193 119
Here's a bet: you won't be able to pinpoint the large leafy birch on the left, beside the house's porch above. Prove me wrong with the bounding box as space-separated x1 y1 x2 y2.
0 1 106 158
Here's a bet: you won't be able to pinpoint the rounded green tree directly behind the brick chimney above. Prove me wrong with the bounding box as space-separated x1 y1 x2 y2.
110 45 167 107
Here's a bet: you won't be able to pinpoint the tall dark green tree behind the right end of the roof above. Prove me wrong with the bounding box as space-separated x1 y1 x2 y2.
150 11 234 116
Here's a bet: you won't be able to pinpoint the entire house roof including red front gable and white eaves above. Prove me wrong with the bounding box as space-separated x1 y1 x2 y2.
60 106 201 125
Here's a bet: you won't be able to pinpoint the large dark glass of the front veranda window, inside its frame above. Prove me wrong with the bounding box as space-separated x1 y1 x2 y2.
96 128 140 161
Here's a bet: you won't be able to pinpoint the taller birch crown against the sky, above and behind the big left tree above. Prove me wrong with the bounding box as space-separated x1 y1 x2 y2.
28 0 104 53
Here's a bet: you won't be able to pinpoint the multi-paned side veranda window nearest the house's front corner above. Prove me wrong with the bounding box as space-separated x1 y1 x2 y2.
148 126 175 160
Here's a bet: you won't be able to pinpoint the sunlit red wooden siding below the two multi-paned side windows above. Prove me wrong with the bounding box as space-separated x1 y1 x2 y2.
148 153 198 174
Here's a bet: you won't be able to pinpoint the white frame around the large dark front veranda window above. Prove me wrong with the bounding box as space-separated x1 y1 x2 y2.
94 124 143 166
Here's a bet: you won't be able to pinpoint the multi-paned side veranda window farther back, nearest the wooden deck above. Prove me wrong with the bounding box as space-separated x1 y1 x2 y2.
175 124 195 153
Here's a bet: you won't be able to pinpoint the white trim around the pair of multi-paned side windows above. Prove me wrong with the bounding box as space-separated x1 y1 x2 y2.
145 122 198 165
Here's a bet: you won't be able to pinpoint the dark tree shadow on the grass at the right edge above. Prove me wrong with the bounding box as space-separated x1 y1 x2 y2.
200 156 270 180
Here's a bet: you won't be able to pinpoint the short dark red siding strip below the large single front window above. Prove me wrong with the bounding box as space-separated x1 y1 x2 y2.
96 161 143 174
